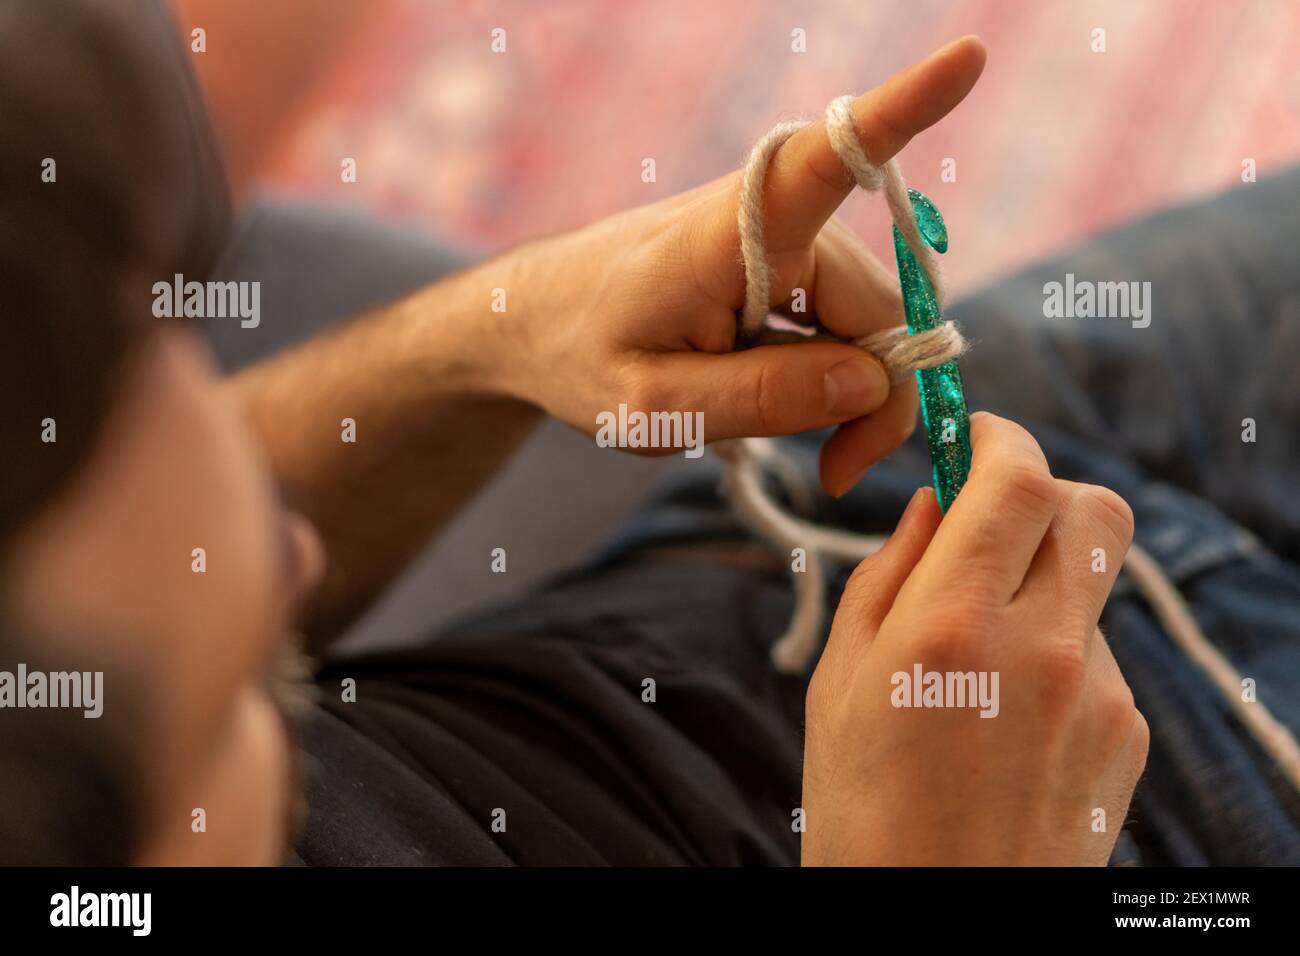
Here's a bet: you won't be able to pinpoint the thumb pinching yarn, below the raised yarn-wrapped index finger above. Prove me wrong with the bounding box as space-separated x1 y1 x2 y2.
663 342 889 441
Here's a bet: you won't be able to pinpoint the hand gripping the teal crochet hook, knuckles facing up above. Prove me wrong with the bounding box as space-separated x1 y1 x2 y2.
802 414 1149 865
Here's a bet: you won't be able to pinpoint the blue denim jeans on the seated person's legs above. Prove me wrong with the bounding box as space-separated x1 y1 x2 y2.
592 170 1300 865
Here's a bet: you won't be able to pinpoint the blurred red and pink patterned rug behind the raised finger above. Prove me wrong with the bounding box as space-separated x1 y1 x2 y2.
268 0 1300 289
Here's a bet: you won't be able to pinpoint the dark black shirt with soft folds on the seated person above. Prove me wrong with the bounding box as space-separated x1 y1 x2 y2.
289 562 803 865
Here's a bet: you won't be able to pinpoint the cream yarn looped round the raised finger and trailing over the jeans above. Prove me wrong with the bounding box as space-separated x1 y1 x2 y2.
712 96 1300 791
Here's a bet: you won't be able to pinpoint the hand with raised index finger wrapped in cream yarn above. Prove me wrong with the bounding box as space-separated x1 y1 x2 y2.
484 36 984 494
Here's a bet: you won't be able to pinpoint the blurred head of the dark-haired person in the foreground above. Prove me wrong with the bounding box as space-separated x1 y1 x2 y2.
0 0 319 864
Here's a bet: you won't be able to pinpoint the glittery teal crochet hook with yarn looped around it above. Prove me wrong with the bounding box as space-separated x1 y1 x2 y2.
893 189 971 512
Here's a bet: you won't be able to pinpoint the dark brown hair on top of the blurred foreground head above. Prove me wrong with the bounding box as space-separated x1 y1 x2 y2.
0 0 225 550
